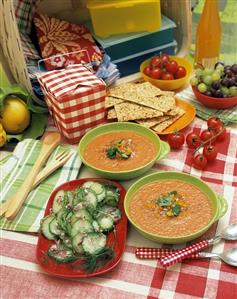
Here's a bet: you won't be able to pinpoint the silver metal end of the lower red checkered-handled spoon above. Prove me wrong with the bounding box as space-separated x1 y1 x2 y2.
198 247 237 267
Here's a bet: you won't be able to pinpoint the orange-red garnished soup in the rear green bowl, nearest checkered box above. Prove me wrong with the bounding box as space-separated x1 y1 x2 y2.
84 130 158 171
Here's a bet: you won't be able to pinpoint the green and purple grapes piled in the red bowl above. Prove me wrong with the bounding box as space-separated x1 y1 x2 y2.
190 62 237 98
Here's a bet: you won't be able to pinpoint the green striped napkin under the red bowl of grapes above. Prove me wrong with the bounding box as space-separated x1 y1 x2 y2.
176 88 237 125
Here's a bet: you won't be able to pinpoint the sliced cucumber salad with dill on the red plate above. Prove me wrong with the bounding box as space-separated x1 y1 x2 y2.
41 181 121 272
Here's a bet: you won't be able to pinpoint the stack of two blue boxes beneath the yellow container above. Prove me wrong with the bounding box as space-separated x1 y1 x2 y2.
86 16 177 77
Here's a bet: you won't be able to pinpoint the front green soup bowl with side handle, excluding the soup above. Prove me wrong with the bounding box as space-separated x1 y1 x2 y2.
124 172 228 244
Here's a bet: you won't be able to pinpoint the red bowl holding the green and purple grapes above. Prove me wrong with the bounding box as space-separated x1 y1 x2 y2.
192 86 237 109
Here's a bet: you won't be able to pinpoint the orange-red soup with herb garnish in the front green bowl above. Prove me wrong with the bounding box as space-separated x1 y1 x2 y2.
129 180 213 237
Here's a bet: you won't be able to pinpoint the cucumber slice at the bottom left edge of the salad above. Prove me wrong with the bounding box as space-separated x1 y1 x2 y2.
48 244 76 263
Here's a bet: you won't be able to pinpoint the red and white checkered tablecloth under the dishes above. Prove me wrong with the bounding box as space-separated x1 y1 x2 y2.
0 119 237 299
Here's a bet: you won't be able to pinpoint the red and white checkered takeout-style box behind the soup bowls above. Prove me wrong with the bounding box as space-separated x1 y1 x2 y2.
38 64 106 144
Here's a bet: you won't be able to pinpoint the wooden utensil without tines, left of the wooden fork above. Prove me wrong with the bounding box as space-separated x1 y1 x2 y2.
5 132 61 219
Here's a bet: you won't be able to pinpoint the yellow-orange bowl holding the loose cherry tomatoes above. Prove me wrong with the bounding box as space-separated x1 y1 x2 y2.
140 56 192 90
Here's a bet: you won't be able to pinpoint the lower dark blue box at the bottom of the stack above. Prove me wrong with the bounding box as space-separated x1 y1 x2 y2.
112 40 177 77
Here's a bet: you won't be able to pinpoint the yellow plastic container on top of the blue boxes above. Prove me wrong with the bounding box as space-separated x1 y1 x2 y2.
87 0 161 38
